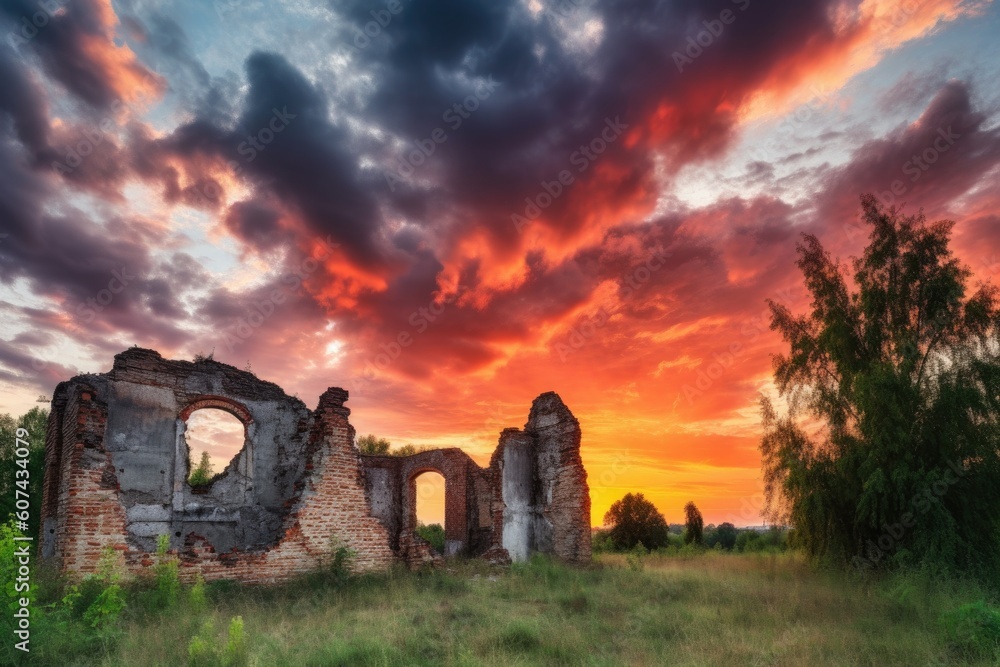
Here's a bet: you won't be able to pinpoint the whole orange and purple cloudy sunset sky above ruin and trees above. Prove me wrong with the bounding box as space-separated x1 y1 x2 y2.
0 0 1000 525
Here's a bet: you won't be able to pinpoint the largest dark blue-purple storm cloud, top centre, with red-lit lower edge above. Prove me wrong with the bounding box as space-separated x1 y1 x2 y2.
337 1 833 252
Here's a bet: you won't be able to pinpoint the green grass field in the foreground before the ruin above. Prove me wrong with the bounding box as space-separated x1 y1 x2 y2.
9 552 998 666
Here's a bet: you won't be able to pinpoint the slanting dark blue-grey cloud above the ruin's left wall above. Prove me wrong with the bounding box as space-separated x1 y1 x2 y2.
141 53 383 266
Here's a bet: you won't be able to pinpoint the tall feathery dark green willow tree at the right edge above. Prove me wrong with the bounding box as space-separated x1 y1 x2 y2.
760 195 1000 582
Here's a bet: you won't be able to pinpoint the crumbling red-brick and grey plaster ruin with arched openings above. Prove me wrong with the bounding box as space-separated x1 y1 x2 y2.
40 348 590 583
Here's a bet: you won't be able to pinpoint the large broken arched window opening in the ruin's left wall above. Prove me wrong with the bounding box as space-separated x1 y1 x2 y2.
184 408 245 487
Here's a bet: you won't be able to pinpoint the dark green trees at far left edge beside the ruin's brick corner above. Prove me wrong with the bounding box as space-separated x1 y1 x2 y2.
0 407 49 535
